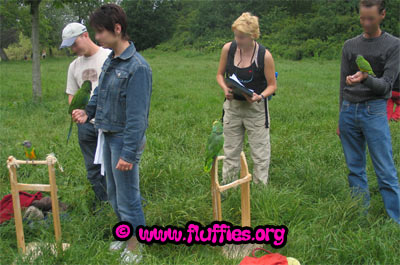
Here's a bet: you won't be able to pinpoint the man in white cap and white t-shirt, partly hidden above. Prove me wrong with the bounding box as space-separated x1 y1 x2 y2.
60 23 111 205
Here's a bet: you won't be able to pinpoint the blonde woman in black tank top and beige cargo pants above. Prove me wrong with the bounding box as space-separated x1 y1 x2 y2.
217 13 276 185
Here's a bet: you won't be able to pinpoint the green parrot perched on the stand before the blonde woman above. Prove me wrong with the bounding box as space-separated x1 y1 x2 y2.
204 121 224 172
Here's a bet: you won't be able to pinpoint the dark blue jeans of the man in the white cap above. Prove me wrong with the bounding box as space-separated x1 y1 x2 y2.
78 122 107 201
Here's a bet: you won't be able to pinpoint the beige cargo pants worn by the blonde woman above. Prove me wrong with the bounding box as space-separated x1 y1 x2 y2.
222 99 271 184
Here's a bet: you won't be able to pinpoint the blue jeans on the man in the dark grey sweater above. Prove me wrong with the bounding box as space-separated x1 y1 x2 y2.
339 99 400 223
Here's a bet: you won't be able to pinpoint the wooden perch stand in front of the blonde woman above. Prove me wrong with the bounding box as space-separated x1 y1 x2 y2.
210 152 251 227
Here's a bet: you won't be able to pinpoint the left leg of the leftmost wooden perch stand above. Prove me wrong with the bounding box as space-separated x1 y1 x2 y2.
9 165 26 253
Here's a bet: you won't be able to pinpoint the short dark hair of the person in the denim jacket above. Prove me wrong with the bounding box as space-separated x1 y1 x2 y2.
89 4 129 40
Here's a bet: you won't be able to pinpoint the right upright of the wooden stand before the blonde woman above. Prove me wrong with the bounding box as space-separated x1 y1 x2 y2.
240 152 251 227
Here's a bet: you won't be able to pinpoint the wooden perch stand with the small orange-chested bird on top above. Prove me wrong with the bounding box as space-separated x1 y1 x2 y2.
7 154 61 254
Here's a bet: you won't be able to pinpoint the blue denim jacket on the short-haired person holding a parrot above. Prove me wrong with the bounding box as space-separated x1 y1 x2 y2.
86 42 152 163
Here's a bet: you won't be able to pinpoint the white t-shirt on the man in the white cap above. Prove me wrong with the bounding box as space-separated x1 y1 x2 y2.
66 47 111 96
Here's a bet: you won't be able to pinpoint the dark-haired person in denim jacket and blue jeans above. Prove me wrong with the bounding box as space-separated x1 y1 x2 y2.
72 4 152 263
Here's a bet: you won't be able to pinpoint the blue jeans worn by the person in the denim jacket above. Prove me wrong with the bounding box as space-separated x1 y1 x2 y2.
103 132 146 235
